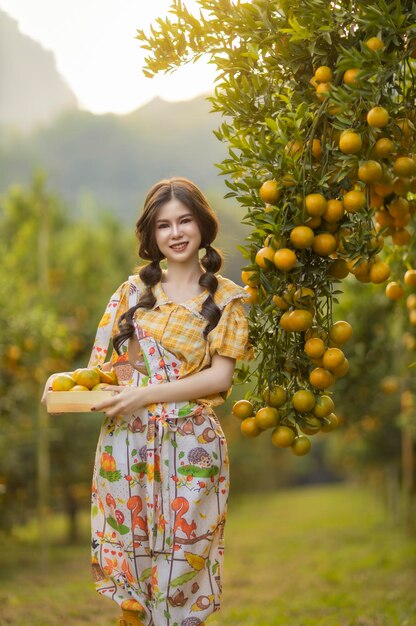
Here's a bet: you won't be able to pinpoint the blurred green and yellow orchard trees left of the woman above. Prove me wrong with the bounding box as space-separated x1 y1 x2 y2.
0 175 134 526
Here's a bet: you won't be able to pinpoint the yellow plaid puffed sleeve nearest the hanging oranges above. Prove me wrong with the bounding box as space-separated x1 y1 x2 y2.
208 298 254 361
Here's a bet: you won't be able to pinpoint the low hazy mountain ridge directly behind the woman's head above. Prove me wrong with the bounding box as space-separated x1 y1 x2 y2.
0 92 231 220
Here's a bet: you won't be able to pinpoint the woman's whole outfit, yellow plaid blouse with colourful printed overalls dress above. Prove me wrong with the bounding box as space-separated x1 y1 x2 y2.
90 276 251 626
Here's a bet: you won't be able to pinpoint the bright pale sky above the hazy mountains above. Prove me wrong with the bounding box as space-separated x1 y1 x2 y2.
0 0 215 113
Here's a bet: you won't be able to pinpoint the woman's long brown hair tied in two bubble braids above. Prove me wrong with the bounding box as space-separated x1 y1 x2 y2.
113 177 222 354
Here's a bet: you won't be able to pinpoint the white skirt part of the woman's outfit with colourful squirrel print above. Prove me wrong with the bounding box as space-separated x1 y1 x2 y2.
92 405 229 626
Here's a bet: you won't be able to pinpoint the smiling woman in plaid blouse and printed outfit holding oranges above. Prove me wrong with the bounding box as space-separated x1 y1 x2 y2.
63 178 251 626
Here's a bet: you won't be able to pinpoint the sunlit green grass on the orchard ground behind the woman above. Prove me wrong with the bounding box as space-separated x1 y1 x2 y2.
0 485 416 626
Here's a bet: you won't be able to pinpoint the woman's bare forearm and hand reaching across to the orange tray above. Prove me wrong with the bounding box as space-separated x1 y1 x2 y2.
92 354 235 417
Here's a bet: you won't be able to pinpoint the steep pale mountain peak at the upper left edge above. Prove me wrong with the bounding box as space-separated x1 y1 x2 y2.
0 11 77 132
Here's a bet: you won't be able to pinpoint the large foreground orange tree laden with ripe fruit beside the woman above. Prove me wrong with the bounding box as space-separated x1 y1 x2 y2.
138 0 416 455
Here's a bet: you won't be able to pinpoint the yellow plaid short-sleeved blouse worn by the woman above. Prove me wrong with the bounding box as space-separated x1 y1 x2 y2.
90 275 253 406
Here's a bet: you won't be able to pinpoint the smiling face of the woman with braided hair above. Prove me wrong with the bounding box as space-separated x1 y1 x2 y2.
155 198 202 263
